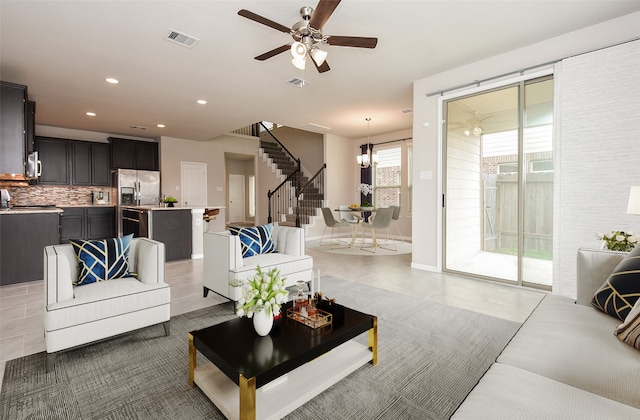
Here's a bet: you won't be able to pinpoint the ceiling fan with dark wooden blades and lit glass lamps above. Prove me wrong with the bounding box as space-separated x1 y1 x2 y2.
238 0 378 73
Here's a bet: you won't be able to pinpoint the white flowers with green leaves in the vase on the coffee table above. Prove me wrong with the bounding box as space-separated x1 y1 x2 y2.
236 266 289 318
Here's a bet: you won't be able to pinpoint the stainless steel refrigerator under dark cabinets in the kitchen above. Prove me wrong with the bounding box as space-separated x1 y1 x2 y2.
113 169 161 236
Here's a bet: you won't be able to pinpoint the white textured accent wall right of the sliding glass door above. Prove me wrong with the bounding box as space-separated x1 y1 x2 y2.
553 37 640 297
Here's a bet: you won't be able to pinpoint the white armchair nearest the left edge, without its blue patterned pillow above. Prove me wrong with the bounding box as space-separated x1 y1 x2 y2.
44 238 171 372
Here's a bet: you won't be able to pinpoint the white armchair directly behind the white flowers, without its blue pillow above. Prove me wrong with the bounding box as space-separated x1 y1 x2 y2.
203 225 313 301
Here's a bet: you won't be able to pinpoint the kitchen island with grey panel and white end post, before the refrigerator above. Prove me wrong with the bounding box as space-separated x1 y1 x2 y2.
122 206 216 261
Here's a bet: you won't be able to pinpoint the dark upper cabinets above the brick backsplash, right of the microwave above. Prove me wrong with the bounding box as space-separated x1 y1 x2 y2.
36 137 111 186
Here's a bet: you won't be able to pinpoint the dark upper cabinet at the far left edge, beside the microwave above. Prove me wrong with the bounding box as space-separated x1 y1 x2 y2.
0 82 27 174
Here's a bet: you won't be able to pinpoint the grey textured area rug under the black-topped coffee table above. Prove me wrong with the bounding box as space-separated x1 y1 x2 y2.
0 276 520 420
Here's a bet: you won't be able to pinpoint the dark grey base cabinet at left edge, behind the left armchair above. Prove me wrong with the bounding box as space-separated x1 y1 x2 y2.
0 212 60 286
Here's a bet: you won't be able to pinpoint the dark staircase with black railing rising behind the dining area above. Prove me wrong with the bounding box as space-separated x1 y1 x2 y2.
260 139 324 226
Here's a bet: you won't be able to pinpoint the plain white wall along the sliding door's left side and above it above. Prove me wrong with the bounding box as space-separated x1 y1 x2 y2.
412 13 640 278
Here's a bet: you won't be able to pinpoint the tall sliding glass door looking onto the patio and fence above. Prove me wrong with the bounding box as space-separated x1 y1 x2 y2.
443 78 553 287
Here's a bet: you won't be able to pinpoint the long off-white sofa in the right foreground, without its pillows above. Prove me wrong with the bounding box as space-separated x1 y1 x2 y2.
452 249 640 420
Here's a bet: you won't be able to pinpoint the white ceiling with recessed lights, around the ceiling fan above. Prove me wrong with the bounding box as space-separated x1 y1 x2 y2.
0 0 640 141
